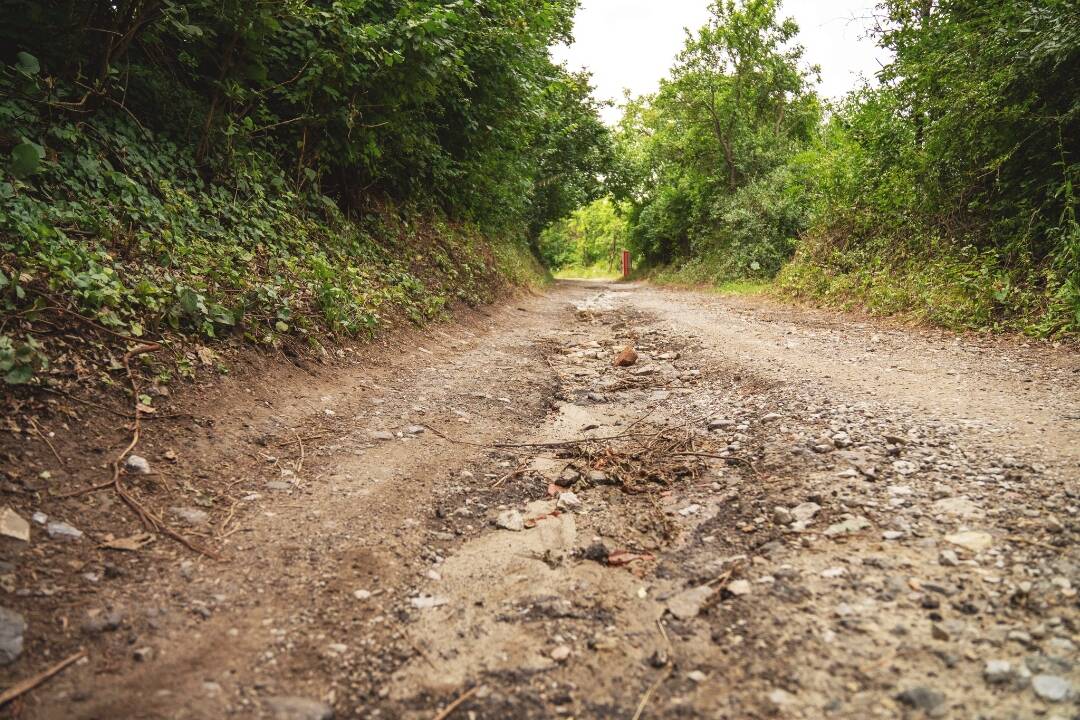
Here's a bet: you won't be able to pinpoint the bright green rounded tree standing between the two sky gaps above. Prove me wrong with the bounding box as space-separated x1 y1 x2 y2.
613 0 820 280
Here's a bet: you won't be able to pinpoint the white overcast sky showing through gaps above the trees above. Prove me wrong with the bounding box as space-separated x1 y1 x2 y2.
553 0 886 122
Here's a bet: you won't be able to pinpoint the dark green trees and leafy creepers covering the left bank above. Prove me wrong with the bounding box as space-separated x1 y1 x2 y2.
0 0 611 381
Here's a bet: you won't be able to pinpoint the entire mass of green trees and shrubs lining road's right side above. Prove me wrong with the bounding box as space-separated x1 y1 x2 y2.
612 0 1080 335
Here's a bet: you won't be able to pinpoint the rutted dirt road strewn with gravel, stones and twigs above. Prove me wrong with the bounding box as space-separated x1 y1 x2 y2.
3 283 1080 720
